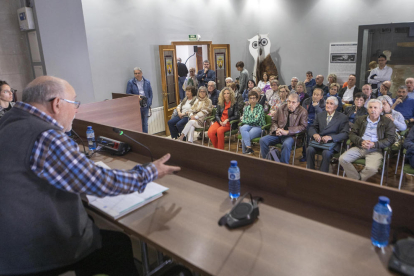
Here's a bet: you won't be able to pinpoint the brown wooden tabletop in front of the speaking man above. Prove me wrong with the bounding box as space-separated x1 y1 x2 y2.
90 153 390 276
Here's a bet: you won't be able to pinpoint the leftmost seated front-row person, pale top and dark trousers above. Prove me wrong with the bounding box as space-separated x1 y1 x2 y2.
168 86 197 139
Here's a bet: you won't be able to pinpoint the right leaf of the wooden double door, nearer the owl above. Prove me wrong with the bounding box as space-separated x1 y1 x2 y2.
210 44 231 90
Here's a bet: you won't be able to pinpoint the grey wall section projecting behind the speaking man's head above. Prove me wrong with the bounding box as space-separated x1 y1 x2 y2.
34 0 95 103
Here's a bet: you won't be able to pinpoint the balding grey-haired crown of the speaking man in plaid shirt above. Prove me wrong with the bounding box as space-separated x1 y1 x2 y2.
22 76 67 104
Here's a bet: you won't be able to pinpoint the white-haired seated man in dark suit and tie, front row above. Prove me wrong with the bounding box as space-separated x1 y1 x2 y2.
306 96 349 172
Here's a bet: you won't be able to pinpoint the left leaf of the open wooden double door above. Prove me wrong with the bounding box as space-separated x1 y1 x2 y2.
159 45 180 136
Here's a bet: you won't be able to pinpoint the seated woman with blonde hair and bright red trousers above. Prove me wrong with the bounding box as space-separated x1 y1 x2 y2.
208 87 240 149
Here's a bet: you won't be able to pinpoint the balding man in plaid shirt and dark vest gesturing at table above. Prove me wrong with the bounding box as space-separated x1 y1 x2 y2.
0 76 180 275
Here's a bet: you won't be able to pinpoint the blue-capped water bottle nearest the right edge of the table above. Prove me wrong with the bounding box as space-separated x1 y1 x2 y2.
371 196 392 247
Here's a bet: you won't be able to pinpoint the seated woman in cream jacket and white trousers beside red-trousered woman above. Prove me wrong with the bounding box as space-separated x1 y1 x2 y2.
178 86 213 143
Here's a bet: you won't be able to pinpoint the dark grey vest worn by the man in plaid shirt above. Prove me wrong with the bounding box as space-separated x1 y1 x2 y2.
0 108 101 275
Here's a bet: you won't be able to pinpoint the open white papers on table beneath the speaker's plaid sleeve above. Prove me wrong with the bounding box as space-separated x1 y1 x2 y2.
87 161 168 219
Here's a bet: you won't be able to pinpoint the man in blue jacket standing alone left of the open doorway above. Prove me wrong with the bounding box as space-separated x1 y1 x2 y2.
126 67 152 133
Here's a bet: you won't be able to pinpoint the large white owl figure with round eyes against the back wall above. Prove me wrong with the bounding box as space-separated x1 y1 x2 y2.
248 34 277 83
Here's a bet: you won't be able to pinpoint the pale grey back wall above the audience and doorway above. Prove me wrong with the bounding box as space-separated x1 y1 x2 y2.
36 0 414 107
